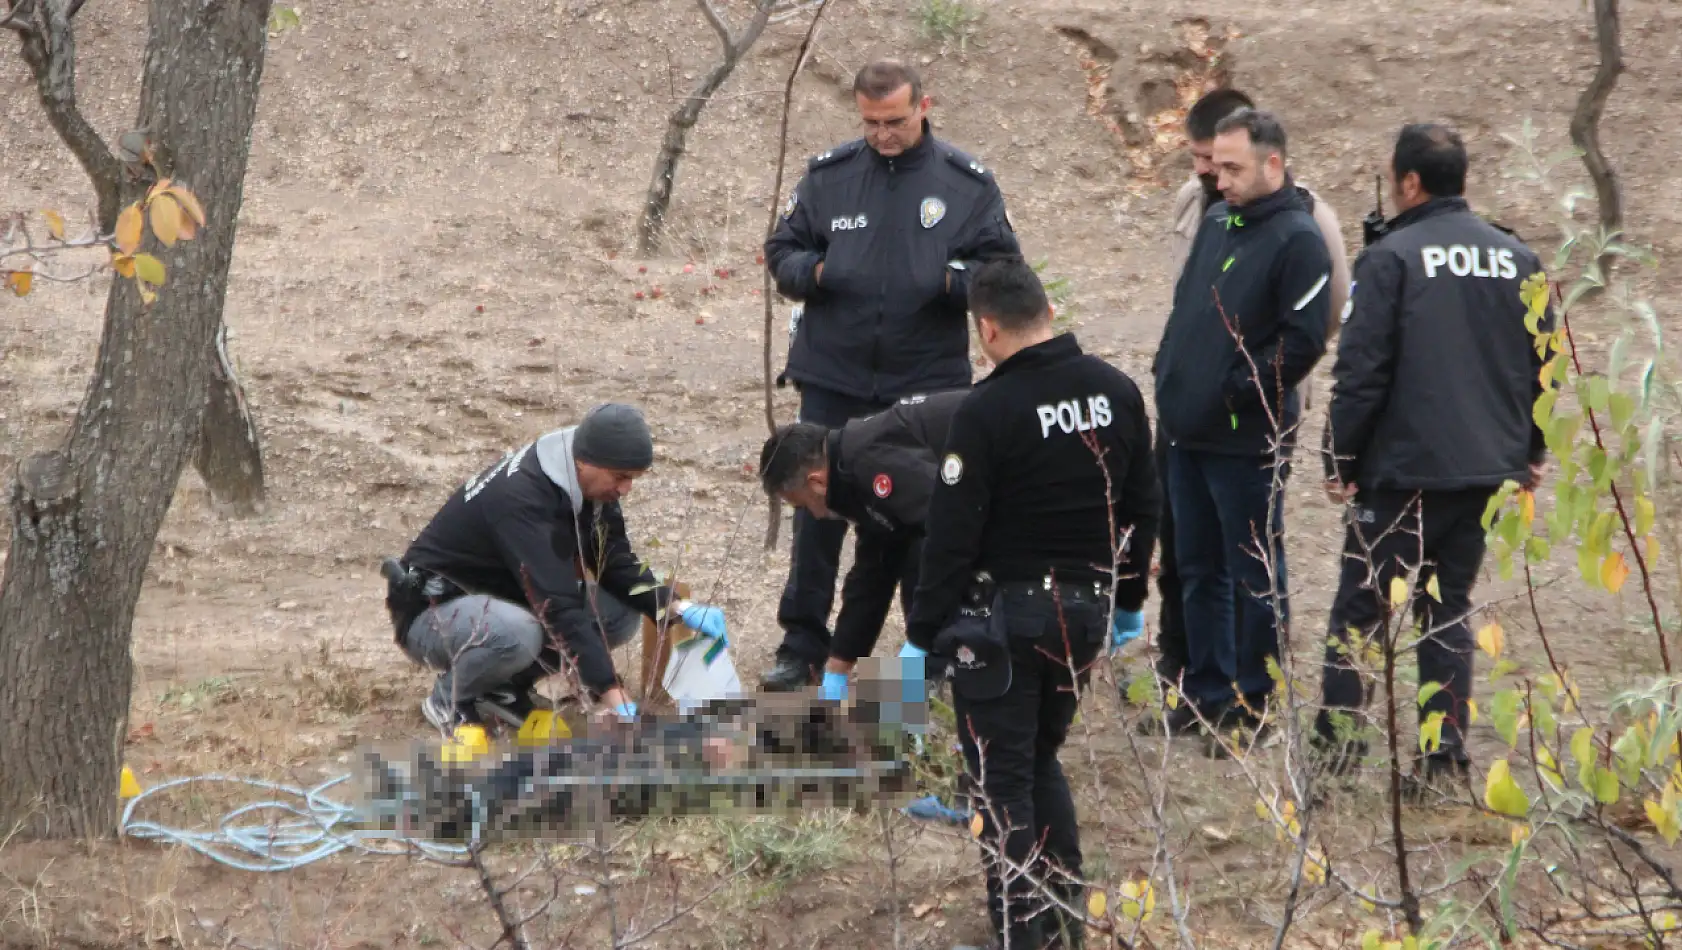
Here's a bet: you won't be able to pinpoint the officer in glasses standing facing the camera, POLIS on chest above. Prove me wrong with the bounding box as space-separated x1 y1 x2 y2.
762 61 1018 689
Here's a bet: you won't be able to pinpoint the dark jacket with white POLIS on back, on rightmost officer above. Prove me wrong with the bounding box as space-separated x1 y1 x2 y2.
1324 197 1554 491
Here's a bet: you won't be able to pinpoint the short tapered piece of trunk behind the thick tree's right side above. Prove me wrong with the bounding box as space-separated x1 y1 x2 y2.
193 326 266 518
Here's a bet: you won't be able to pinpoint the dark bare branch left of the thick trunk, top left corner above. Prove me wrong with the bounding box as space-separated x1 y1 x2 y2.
5 0 123 230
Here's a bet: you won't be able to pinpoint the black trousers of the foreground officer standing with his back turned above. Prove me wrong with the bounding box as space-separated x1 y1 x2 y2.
952 582 1108 947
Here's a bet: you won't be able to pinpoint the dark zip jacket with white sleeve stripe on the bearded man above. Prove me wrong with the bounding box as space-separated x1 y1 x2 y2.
1150 178 1332 456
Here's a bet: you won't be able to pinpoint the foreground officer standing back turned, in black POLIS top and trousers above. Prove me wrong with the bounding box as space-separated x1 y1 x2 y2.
902 257 1161 948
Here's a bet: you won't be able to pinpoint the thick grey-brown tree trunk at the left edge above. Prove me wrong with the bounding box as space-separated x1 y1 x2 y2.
0 0 271 837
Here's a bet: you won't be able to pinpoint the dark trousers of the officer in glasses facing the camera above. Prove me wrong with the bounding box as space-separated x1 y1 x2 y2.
777 385 891 668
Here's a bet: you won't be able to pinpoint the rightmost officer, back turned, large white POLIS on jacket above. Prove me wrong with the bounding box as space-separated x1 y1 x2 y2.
1315 124 1552 787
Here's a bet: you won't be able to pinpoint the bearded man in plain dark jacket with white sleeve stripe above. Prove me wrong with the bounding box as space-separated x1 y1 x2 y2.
1154 109 1332 733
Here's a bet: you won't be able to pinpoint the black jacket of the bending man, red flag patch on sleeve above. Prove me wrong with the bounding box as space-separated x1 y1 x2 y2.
826 388 969 661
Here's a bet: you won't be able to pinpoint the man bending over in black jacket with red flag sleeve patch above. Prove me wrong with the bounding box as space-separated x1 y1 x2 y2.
759 388 969 699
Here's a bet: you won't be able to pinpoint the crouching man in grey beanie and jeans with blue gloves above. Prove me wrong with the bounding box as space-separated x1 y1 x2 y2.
385 404 725 731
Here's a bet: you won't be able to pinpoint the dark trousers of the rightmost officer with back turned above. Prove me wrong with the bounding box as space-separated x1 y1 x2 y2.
1315 488 1494 762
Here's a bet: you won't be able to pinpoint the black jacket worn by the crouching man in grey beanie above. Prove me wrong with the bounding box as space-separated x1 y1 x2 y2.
404 442 673 699
